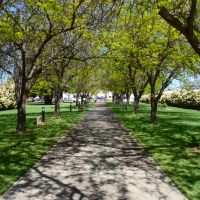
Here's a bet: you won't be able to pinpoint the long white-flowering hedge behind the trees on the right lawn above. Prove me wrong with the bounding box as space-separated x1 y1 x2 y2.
141 91 200 110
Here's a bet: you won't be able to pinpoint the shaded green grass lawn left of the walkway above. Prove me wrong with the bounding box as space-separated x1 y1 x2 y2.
0 103 91 194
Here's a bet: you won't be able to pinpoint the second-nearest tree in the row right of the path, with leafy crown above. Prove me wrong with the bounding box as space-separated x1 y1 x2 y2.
97 4 151 113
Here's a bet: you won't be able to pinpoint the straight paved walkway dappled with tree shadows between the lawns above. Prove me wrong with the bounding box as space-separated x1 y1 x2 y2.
0 104 186 200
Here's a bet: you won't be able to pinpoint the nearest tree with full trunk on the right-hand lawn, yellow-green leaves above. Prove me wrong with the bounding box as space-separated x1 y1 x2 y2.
143 20 196 123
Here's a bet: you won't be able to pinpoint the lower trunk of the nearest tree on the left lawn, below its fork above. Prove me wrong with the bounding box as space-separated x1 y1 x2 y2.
16 94 26 134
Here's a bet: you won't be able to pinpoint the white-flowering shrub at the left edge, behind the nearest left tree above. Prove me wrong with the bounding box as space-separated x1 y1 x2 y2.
0 81 16 110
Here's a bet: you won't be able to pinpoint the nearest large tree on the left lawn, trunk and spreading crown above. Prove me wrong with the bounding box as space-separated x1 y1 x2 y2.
0 0 93 133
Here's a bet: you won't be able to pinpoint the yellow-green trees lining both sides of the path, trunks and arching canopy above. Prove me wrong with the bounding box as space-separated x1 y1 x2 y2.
0 0 200 134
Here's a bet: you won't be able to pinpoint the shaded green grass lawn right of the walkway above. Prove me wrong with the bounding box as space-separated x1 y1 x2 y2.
108 103 200 200
